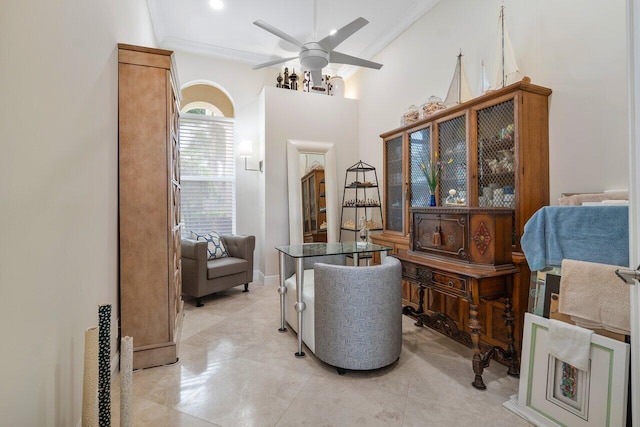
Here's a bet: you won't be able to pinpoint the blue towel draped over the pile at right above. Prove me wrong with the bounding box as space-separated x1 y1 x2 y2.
520 206 629 271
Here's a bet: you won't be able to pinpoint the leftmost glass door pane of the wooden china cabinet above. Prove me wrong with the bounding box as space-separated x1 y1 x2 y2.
384 135 404 233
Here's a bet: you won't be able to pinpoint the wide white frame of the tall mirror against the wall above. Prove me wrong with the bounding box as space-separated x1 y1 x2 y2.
287 140 338 245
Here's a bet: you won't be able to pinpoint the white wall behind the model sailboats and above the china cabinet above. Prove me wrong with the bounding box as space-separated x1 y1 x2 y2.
347 0 628 204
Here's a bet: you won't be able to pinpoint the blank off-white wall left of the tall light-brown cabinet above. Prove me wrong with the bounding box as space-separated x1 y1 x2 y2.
0 0 155 426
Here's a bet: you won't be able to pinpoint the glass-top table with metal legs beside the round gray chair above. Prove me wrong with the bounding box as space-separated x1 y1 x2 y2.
276 242 392 357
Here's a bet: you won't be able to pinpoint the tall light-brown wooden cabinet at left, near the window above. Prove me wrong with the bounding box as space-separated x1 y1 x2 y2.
118 44 182 369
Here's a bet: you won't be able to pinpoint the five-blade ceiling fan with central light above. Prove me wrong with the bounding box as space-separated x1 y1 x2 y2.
253 7 382 86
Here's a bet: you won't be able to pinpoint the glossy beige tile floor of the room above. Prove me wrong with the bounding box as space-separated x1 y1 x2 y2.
112 285 529 427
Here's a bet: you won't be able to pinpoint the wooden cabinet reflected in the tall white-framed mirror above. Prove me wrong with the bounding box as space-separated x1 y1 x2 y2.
301 170 327 243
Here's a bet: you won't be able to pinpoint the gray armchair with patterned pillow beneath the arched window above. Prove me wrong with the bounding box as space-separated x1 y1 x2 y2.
181 235 256 307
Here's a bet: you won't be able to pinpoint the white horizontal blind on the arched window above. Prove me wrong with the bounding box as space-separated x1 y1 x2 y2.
180 114 236 237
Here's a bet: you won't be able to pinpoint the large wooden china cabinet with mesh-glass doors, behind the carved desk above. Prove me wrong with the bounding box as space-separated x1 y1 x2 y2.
371 77 551 372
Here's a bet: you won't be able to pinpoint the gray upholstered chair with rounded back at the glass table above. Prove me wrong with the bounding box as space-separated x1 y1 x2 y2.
314 256 402 374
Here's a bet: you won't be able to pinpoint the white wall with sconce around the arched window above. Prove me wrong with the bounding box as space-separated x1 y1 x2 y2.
175 52 278 281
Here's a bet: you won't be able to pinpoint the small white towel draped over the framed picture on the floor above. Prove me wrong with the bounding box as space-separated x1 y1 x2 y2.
549 319 593 371
